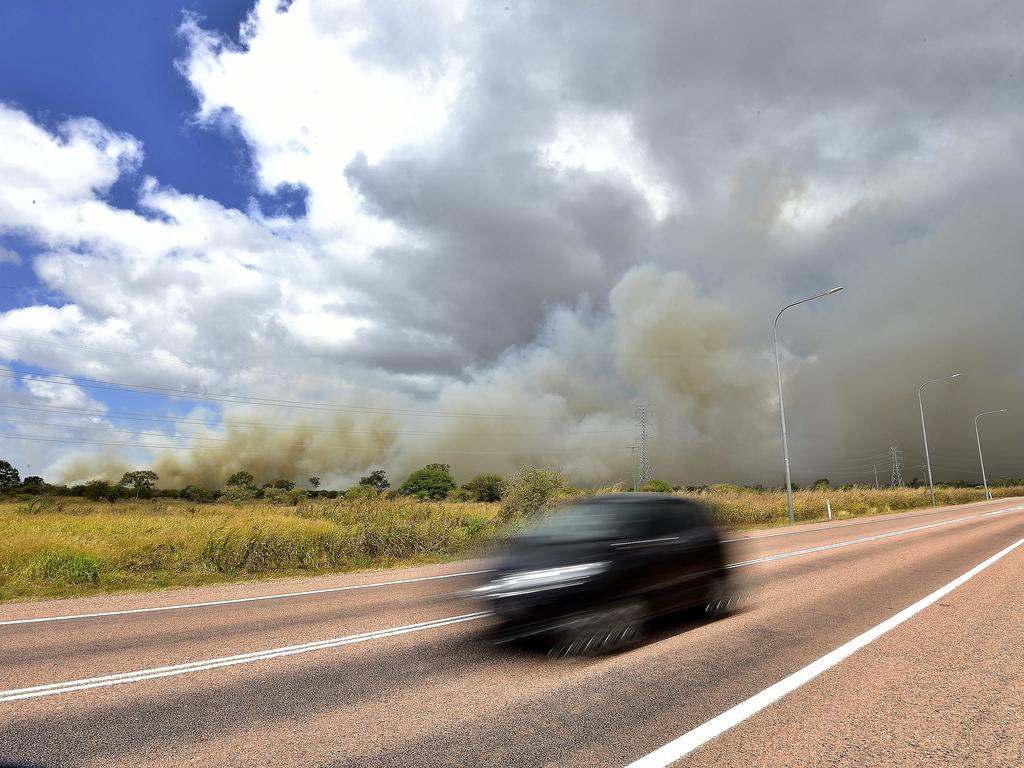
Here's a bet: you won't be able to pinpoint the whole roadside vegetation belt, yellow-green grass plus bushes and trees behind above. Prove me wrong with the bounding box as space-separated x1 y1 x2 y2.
0 462 1024 601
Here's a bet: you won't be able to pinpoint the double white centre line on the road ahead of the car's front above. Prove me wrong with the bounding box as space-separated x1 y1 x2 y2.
0 611 487 703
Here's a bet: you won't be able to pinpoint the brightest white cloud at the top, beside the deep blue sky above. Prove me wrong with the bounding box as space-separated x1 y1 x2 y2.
180 0 465 233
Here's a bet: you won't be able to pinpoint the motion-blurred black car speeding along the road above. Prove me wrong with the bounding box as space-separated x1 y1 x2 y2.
471 494 735 655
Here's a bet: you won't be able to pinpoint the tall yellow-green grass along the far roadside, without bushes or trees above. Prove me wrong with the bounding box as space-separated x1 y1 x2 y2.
0 485 1024 601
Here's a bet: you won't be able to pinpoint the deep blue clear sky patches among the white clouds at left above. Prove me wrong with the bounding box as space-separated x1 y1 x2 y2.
0 0 303 462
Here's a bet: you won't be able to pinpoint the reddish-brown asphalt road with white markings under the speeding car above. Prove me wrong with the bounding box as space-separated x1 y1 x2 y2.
0 499 1024 768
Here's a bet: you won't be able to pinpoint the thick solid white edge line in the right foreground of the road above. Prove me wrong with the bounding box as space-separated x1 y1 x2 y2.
627 539 1024 768
